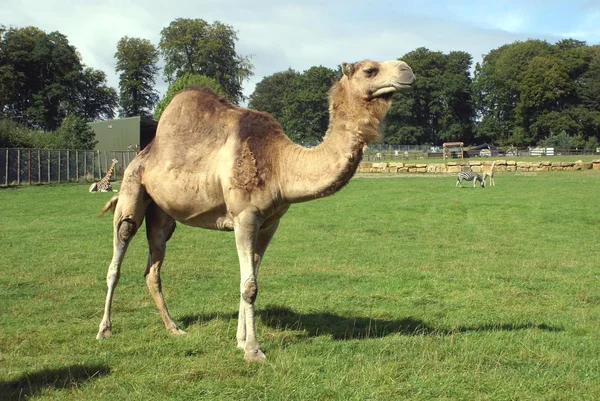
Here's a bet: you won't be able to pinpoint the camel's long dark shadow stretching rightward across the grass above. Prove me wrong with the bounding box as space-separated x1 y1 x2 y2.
180 305 563 340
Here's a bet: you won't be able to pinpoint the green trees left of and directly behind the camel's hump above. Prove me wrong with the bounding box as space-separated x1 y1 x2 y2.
0 18 253 149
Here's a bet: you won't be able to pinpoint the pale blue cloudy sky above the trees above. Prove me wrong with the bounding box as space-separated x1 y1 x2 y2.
0 0 600 103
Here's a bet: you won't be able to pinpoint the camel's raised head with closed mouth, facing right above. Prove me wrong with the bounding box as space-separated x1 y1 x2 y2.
342 60 416 101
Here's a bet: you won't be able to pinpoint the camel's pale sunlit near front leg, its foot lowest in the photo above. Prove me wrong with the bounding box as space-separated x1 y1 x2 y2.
234 213 265 362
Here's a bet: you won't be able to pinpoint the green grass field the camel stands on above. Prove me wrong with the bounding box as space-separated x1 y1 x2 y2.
0 171 600 401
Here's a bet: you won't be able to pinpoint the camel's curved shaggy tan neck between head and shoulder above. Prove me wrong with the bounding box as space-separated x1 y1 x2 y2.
280 84 387 203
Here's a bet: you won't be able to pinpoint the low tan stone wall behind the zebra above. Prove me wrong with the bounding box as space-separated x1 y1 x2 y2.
358 160 600 173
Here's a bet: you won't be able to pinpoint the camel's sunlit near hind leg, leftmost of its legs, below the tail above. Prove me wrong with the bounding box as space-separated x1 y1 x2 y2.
96 184 149 340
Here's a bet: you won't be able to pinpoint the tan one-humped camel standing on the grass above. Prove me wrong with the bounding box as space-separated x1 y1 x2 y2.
97 60 415 362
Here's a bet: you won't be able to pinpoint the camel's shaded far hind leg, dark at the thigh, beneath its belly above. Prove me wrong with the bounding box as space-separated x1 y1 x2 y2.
145 203 185 335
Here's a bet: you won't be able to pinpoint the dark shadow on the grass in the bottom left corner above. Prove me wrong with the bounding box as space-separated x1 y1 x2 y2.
0 365 110 401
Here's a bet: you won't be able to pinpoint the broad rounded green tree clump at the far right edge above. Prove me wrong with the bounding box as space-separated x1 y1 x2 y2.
473 39 600 146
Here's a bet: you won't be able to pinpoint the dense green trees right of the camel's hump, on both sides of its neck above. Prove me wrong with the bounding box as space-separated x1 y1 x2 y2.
249 39 600 149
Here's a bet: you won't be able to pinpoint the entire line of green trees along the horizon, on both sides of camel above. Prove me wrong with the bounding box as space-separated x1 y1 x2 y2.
0 18 600 149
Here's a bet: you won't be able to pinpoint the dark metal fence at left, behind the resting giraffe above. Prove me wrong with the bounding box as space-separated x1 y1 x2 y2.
0 148 135 186
